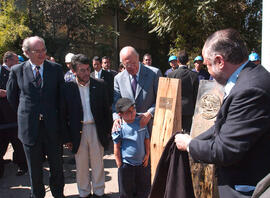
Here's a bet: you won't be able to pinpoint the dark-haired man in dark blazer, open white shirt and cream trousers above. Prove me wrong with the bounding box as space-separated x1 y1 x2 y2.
64 54 111 197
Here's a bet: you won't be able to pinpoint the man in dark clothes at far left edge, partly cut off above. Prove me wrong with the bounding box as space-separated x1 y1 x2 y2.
0 51 27 178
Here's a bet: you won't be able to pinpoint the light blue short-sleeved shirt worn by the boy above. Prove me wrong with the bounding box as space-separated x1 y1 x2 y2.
112 117 149 166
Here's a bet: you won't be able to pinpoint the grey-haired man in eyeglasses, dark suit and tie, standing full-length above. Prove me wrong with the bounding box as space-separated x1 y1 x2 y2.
7 36 64 198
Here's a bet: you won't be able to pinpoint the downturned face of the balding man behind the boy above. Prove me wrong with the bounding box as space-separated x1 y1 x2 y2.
121 52 139 75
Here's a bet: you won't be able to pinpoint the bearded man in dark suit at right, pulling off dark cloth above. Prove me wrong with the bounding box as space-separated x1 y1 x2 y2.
175 29 270 198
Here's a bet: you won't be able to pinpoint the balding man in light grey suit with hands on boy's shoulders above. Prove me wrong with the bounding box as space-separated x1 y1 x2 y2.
112 46 162 196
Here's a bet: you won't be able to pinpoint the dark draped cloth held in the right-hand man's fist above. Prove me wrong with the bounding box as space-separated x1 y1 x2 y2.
149 132 195 198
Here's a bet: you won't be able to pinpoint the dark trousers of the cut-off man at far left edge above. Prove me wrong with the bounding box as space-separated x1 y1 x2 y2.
0 128 27 169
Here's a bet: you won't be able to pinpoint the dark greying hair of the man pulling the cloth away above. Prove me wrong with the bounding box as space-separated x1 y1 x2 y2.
204 28 248 64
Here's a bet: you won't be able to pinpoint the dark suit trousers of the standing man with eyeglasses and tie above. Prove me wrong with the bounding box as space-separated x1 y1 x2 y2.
23 121 64 198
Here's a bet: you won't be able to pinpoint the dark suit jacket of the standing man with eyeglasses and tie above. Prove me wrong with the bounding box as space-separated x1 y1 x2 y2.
7 60 64 146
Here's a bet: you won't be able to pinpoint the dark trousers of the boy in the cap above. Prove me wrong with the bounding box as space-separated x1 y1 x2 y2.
118 163 151 198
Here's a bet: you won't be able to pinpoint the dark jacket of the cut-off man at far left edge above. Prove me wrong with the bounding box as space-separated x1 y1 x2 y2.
0 66 17 125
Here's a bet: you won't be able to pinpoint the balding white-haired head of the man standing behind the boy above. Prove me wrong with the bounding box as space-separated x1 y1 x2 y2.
120 46 139 75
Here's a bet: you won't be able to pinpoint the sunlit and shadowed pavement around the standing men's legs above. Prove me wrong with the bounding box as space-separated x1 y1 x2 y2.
0 145 118 198
